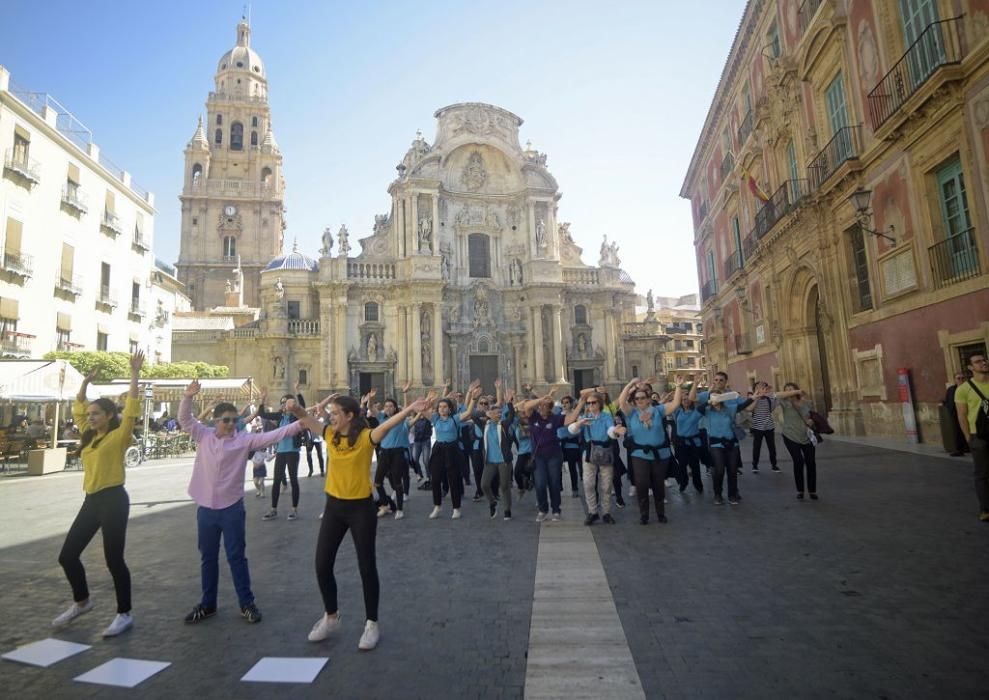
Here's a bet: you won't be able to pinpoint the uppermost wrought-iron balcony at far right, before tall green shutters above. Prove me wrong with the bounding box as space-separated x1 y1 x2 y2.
869 17 962 130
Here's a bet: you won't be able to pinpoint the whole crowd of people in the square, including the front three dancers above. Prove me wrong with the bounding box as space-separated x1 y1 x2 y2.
46 352 989 650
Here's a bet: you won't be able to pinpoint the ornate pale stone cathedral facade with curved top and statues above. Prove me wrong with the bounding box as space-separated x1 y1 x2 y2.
173 20 666 395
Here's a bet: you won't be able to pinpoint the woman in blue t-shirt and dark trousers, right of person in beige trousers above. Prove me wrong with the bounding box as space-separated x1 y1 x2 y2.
618 377 683 525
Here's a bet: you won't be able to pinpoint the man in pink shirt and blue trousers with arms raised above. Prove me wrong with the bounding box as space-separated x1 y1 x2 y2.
179 381 306 623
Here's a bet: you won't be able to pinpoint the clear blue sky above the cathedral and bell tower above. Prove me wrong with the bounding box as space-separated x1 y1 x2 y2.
0 0 745 296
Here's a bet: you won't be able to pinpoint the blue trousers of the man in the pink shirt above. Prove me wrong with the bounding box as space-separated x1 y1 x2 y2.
196 498 253 608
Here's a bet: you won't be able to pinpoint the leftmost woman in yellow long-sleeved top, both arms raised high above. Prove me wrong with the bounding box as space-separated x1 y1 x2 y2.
52 350 144 637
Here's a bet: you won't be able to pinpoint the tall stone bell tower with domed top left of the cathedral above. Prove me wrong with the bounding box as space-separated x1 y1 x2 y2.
176 18 285 310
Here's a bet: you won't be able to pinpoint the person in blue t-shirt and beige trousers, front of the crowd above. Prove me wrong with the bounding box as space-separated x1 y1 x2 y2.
564 389 625 525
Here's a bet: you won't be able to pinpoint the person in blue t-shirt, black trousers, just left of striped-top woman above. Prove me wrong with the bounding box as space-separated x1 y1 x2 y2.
691 372 752 506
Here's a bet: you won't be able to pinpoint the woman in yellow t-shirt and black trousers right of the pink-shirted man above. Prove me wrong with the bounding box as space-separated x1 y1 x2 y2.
302 396 429 651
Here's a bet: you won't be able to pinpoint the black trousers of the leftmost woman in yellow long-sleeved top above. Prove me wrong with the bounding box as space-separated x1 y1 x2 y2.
58 485 131 613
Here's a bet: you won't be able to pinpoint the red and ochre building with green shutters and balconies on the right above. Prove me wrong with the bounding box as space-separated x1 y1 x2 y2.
681 0 989 441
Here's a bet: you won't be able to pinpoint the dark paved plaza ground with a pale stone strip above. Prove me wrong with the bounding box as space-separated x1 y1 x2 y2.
0 440 989 698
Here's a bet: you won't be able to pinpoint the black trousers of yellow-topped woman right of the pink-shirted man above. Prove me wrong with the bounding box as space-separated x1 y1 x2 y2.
316 495 381 621
